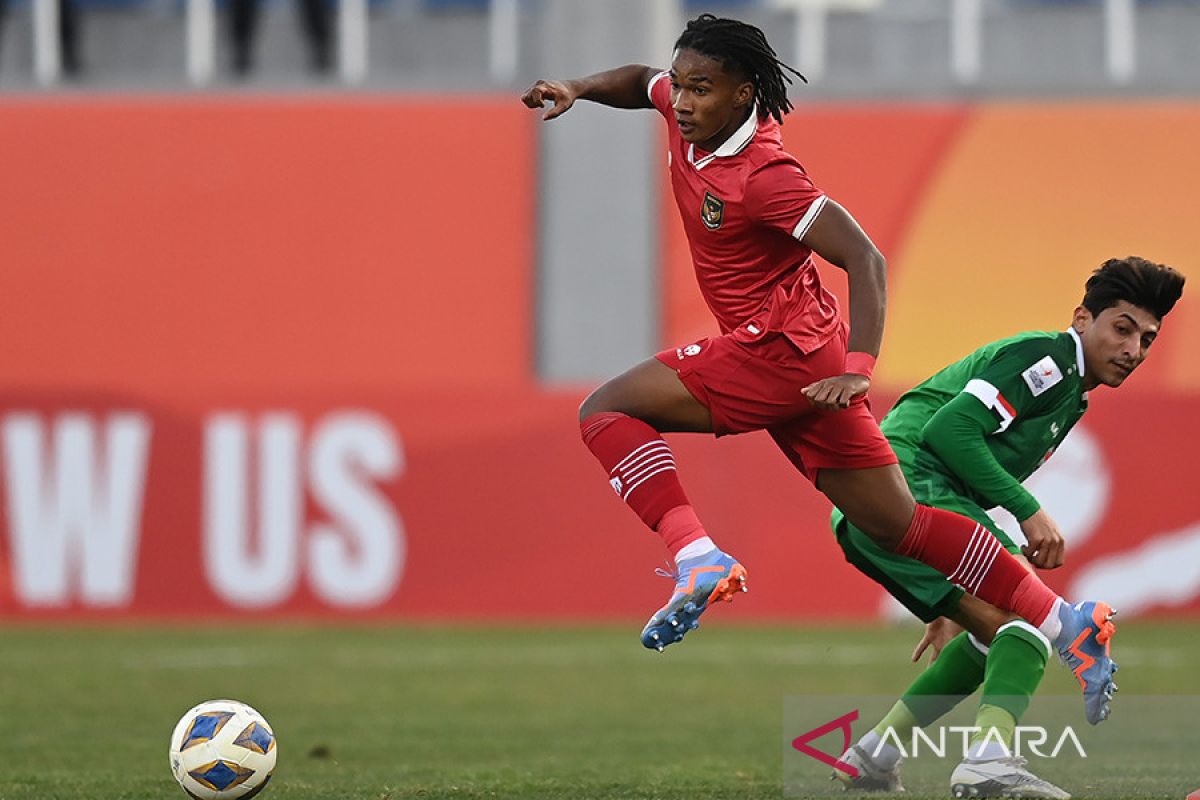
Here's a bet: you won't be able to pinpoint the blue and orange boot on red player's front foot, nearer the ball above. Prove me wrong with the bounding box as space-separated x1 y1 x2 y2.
642 547 746 652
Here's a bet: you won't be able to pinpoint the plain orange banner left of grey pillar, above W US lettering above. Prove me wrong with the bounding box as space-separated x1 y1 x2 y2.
0 96 536 397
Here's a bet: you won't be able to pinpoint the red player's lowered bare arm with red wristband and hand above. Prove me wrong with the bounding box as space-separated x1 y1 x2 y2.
804 200 887 410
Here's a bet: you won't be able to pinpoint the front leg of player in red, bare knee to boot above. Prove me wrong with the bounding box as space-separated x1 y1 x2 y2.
580 359 746 652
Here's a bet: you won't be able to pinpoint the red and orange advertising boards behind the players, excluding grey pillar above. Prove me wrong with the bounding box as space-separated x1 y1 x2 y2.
0 97 1200 620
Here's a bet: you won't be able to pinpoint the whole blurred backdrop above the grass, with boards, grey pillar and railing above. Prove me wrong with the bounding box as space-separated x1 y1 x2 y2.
0 0 1200 627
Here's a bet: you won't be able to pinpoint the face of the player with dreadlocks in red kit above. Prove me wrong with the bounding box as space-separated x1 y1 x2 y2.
671 49 754 152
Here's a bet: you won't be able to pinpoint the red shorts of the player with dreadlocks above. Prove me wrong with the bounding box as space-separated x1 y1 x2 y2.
656 325 896 482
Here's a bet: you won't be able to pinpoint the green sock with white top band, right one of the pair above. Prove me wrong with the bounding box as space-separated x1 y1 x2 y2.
971 620 1050 758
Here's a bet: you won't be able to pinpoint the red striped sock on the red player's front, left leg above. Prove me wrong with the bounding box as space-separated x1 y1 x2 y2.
580 413 708 557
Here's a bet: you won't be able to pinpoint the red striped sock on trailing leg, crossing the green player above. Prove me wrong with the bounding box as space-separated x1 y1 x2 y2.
896 504 1058 625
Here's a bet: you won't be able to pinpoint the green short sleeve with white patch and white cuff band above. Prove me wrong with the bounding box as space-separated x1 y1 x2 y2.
962 338 1072 434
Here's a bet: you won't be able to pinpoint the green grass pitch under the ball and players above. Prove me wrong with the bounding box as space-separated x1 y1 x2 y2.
0 619 1200 800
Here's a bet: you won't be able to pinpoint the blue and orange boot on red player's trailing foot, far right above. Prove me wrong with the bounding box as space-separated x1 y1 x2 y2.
1055 601 1117 724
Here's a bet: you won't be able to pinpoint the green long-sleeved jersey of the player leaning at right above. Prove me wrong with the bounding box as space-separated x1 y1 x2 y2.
881 329 1087 519
